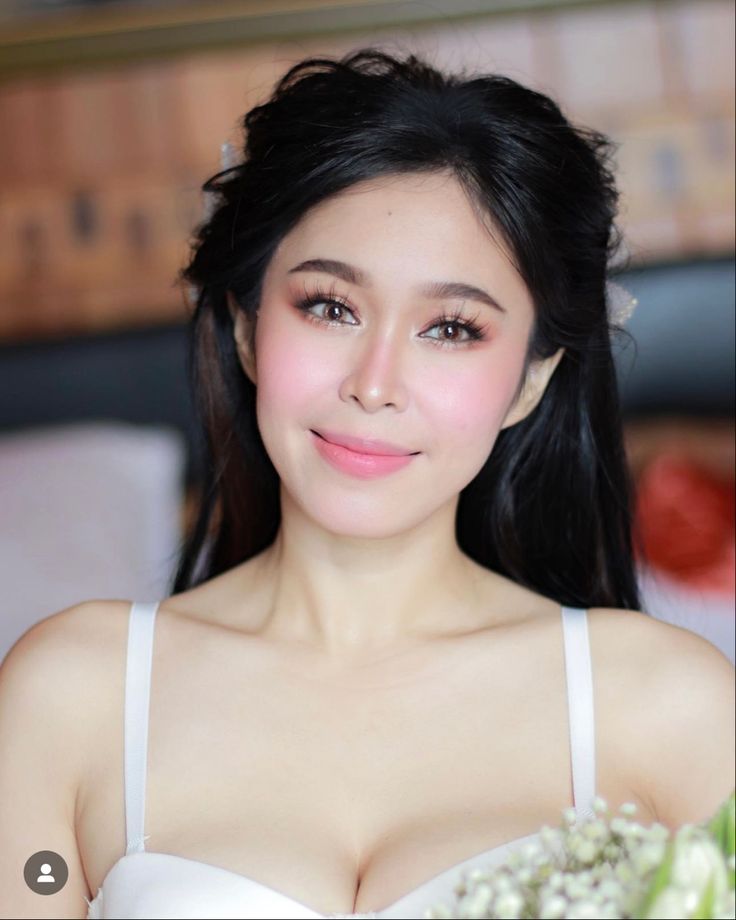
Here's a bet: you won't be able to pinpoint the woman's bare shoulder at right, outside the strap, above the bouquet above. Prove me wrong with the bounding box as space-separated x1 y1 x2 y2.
589 608 736 828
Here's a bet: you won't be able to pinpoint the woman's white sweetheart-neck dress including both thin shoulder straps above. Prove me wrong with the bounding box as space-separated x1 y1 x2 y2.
85 603 595 920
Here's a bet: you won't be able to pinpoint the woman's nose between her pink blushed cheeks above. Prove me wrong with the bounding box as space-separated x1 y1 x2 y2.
340 330 407 412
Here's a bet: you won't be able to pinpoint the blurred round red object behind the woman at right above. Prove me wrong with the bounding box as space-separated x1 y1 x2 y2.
636 451 736 595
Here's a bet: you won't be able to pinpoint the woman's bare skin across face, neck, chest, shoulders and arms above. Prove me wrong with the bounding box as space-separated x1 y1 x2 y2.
0 175 735 918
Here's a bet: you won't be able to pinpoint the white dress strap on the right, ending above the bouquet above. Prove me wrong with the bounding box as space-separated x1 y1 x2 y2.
562 607 595 817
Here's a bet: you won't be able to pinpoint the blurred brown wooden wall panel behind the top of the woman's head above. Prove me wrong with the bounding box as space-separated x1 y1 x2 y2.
0 0 734 341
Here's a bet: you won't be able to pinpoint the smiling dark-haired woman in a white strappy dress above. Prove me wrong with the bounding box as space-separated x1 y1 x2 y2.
0 49 733 918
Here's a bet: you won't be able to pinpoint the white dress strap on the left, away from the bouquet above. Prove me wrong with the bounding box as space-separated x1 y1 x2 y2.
125 603 158 855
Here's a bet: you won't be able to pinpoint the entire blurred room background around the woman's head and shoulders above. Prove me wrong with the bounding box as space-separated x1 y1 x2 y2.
0 0 735 661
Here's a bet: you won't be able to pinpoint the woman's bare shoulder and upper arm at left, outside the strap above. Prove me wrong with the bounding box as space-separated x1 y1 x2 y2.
0 601 132 917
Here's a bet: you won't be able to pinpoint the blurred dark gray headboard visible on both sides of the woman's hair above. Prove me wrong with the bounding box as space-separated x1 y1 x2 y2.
0 256 735 482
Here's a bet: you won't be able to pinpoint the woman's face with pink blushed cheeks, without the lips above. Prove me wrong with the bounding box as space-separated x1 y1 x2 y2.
230 174 556 537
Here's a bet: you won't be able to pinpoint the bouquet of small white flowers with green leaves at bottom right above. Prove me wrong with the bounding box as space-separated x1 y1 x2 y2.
424 792 736 920
